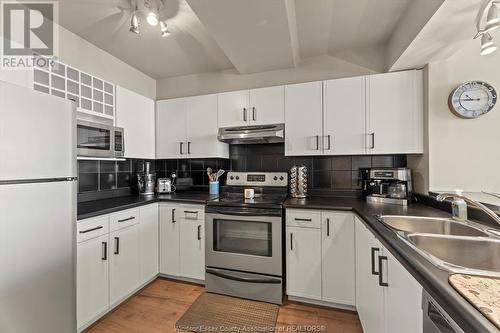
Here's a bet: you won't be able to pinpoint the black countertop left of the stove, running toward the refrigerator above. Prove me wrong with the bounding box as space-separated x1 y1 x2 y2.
77 192 217 220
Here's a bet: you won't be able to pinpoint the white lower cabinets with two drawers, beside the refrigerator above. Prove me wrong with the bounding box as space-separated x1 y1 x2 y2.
76 203 158 331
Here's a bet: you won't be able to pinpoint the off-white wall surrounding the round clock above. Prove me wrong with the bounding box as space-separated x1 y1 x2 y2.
410 41 500 193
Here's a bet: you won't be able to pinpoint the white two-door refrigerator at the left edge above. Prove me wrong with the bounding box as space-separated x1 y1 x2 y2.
0 81 77 333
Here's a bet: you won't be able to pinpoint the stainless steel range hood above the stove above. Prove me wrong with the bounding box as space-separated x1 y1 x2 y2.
217 124 285 144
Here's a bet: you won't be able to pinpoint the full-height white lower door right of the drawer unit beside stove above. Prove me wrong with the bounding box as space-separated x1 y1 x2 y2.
321 213 356 306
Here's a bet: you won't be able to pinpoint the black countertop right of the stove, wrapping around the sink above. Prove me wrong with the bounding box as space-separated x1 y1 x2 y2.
284 197 498 332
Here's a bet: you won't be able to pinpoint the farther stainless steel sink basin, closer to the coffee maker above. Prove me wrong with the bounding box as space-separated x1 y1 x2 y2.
378 215 489 237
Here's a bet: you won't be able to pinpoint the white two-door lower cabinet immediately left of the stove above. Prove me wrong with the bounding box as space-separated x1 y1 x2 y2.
159 203 205 281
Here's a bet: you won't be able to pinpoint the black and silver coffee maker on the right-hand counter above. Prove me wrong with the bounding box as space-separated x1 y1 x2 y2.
361 168 413 206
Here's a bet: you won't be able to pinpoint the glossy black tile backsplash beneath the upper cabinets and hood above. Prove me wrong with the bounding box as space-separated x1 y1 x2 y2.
78 143 407 201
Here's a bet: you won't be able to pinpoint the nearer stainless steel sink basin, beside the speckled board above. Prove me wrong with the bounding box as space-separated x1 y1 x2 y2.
407 234 500 273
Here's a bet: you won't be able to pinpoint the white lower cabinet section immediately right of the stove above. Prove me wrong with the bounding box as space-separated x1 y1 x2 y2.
286 209 355 307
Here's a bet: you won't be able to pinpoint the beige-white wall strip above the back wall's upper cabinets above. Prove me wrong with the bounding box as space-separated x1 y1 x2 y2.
156 55 374 100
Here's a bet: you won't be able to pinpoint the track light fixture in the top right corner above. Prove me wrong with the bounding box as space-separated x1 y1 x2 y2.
474 0 500 55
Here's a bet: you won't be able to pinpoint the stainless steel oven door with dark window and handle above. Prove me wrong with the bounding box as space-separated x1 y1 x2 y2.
205 207 282 276
